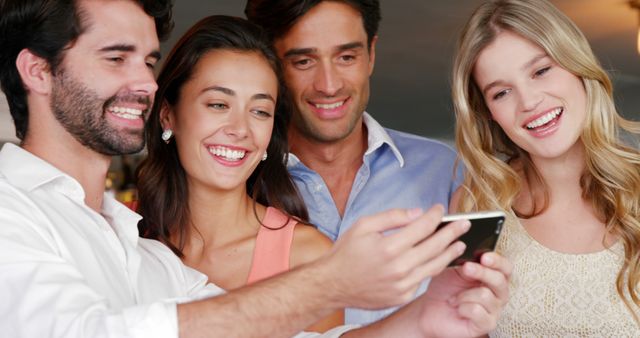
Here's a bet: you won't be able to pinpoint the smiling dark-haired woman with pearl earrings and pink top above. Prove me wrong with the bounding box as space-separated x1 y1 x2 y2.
138 16 343 331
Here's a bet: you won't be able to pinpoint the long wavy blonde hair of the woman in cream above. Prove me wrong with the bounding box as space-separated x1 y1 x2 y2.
452 0 640 322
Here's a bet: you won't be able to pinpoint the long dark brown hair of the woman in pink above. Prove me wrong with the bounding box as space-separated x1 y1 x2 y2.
137 15 309 257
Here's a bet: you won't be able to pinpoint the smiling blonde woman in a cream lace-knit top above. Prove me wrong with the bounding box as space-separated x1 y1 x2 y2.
452 0 640 337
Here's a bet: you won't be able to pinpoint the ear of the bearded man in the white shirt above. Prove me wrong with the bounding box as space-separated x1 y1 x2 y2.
16 48 52 95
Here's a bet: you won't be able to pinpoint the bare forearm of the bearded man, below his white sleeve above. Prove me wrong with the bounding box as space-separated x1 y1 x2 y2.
178 263 344 338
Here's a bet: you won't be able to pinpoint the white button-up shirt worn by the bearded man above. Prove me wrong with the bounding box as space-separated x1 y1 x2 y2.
0 144 356 337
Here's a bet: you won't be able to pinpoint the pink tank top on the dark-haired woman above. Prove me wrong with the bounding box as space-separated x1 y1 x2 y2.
247 207 298 284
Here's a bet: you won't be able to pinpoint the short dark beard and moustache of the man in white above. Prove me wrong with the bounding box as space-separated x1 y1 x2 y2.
51 68 150 156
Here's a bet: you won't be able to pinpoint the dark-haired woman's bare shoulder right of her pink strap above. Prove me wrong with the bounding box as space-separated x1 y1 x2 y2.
290 224 333 267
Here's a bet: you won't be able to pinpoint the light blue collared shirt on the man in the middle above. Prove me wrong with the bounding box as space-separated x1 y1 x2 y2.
288 113 462 324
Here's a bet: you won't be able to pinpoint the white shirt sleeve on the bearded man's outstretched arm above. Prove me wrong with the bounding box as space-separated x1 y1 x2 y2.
0 203 178 338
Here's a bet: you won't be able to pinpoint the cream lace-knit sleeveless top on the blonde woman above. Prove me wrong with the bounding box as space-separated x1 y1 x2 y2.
490 216 640 337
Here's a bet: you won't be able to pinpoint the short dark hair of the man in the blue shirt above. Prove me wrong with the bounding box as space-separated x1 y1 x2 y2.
244 0 381 47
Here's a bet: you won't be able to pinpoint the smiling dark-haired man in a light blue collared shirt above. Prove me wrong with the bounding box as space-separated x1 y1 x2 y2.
245 0 459 324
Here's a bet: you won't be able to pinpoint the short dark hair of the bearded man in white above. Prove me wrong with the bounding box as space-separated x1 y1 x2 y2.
0 0 173 140
